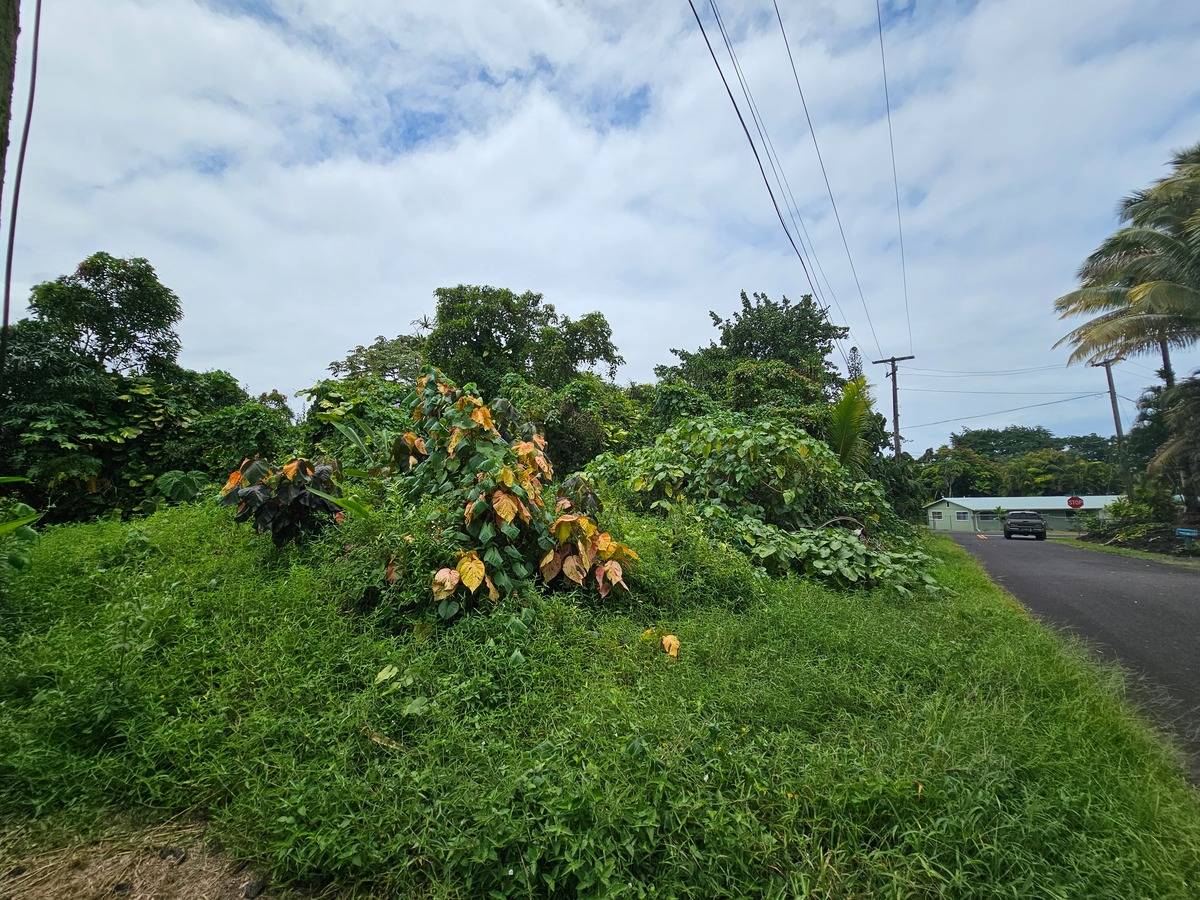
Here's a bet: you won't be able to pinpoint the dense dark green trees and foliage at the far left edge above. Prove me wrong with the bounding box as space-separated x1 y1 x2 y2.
0 253 292 521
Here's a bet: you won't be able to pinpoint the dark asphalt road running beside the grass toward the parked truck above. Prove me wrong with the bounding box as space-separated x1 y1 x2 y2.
953 534 1200 780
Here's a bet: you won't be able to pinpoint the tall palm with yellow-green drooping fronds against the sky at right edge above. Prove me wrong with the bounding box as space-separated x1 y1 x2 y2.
1055 144 1200 386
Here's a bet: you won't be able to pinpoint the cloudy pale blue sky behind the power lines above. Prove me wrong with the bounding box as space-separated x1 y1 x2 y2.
6 0 1200 455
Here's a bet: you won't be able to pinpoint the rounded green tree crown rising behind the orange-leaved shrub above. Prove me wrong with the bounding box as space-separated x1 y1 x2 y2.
425 284 625 397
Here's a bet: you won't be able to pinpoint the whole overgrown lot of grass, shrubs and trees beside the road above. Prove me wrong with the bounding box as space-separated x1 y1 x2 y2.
7 244 1200 896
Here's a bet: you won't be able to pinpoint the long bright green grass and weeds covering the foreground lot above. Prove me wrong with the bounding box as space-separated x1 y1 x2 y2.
0 506 1200 898
